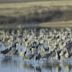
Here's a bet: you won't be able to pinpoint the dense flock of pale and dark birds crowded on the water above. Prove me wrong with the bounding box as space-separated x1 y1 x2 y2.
0 28 72 60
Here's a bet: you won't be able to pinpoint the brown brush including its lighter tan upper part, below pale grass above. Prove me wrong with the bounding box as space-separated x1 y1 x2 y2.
0 6 72 24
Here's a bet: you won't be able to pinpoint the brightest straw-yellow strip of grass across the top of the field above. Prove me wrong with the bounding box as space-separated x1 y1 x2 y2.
0 0 72 8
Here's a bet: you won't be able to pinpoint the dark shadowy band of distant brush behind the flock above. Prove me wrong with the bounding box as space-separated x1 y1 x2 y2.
0 9 72 24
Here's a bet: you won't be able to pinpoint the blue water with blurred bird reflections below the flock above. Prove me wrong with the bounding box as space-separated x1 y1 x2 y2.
0 56 72 72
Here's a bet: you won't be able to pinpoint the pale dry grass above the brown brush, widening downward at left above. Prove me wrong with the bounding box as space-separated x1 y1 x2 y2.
0 1 72 16
